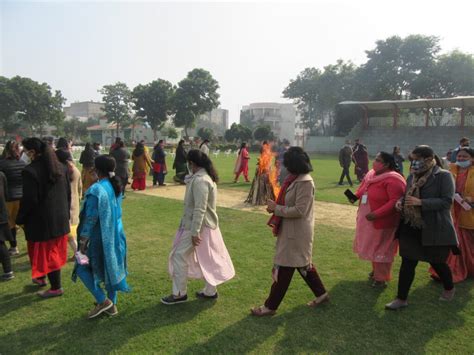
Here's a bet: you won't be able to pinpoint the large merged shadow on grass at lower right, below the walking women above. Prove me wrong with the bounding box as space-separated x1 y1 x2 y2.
182 281 469 354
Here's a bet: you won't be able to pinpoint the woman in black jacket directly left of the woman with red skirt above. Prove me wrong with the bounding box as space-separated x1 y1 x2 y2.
0 141 26 256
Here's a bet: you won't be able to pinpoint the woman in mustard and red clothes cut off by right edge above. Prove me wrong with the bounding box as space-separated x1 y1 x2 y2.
430 147 474 282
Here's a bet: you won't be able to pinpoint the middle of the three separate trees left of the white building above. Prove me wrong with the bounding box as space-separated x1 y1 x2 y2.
132 79 175 140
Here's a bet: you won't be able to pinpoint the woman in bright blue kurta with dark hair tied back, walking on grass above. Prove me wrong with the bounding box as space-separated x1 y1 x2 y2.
73 155 129 318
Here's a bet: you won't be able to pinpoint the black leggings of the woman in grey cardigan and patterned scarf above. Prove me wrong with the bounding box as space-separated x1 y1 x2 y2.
397 258 454 301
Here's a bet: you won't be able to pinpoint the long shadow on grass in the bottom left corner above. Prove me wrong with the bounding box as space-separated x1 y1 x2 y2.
0 295 213 353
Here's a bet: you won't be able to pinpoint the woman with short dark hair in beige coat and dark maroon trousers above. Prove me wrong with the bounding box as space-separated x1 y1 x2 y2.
251 147 329 317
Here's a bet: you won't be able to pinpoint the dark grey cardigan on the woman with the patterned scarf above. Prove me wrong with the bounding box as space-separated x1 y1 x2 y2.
407 166 458 246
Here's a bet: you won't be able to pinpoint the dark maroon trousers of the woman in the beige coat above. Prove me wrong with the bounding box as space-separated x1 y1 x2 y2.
265 265 326 310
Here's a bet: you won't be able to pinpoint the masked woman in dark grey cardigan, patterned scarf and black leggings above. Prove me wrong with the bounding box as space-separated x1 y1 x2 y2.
385 145 458 310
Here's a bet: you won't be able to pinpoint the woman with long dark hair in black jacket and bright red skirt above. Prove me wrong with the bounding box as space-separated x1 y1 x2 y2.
16 138 71 298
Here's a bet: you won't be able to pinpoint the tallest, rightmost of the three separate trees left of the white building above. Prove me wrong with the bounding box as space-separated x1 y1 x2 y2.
173 69 219 136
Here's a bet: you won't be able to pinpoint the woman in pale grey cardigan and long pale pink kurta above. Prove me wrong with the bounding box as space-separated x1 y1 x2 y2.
161 149 235 305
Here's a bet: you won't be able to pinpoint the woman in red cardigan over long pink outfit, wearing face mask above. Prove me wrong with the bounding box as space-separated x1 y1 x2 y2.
353 152 406 287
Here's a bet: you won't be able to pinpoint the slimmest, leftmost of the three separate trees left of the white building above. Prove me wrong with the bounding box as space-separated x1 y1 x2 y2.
99 82 132 137
